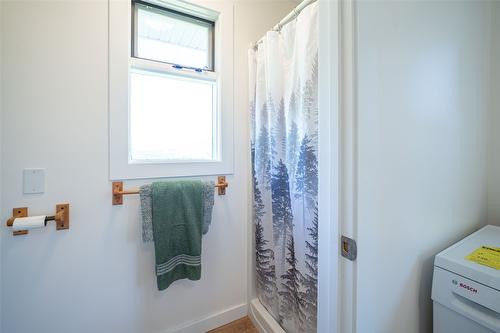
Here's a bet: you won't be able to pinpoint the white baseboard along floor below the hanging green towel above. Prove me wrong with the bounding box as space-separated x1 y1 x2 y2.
165 303 248 333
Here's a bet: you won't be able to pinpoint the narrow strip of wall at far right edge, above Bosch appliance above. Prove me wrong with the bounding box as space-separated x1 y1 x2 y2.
488 1 500 225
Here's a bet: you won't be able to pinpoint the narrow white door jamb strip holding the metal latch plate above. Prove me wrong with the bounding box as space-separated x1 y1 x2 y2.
338 1 358 333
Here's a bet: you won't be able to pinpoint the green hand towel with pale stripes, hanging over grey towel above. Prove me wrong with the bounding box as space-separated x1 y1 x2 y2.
151 181 204 290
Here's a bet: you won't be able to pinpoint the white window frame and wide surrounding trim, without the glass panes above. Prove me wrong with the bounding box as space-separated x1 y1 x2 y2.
109 0 234 180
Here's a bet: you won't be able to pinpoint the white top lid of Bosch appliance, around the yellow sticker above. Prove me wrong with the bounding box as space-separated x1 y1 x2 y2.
434 225 500 291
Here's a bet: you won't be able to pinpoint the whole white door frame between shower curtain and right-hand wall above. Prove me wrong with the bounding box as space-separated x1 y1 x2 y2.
318 0 357 333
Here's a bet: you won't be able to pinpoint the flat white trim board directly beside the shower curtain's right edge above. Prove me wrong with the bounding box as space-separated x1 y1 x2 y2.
318 0 344 333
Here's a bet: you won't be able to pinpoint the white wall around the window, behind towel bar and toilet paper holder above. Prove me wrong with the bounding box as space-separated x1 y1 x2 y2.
0 0 295 333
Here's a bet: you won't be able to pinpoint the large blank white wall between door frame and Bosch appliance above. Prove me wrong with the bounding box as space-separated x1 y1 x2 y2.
356 1 491 333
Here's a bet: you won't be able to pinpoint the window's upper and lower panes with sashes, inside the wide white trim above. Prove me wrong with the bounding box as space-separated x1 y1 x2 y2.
129 1 219 163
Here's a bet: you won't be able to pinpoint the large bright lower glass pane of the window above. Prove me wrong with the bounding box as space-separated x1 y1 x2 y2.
130 70 218 161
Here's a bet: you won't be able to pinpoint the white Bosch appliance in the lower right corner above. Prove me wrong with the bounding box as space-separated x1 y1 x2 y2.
432 225 500 333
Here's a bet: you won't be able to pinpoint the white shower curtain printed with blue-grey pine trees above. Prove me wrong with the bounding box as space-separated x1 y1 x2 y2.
249 3 318 333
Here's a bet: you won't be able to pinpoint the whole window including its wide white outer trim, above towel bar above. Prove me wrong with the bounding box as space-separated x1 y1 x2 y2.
109 0 233 179
